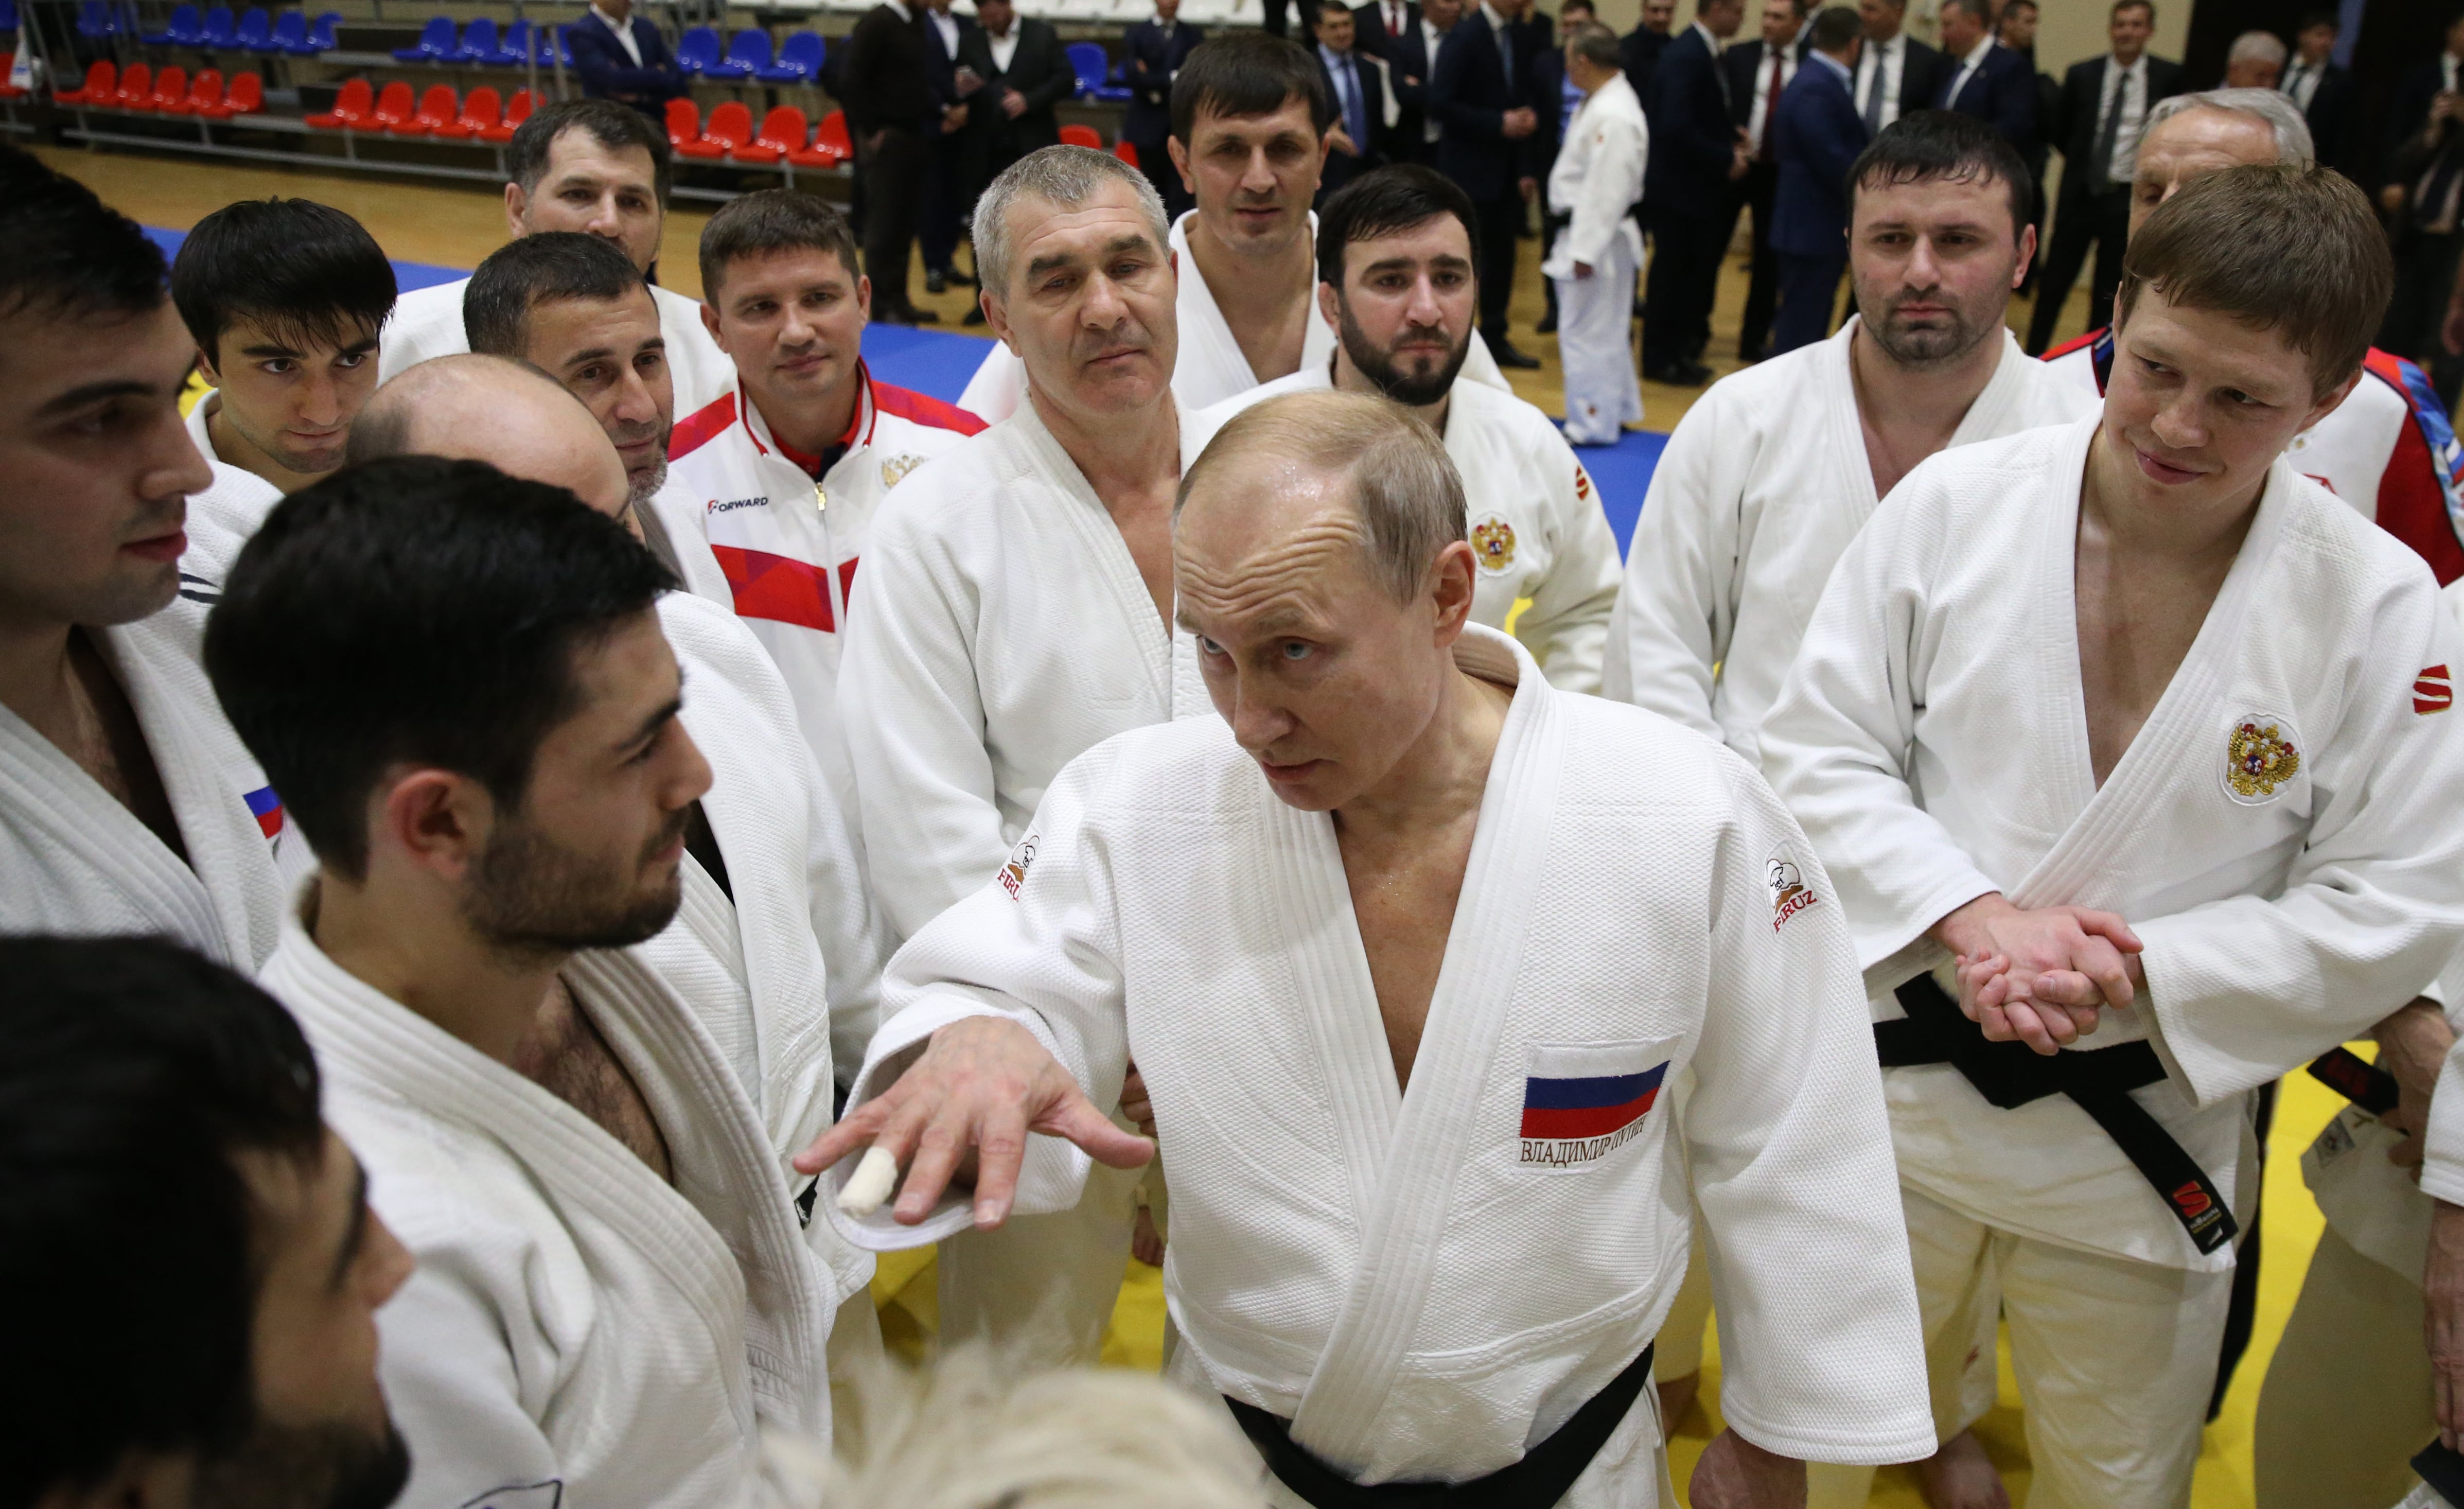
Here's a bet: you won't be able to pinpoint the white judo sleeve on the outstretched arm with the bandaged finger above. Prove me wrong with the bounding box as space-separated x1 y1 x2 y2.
820 740 1129 1250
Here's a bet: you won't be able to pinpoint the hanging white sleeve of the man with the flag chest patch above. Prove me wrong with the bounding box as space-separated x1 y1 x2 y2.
1683 752 1934 1465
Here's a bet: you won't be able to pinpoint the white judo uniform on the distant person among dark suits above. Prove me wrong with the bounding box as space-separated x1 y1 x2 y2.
1540 74 1651 446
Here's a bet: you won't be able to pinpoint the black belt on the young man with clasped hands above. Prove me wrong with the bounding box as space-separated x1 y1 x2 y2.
1873 974 2240 1253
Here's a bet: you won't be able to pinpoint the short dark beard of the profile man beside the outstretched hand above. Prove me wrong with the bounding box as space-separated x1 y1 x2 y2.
463 806 692 954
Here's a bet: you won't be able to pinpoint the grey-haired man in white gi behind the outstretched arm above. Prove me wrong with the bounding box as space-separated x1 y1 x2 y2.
838 146 1205 1361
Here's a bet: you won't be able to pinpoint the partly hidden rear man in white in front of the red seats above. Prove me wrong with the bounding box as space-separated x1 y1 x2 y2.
377 99 729 412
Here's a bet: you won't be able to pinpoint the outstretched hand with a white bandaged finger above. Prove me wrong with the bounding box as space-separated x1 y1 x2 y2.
794 1016 1156 1231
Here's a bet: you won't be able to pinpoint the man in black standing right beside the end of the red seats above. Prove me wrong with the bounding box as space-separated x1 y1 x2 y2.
838 0 941 325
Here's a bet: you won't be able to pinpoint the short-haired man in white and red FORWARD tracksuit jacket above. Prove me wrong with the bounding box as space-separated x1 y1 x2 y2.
663 190 983 811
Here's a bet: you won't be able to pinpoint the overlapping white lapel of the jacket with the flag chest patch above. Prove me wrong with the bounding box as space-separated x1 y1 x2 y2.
1291 626 1564 1462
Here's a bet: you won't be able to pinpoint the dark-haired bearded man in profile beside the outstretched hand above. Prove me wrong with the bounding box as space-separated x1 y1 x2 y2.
204 456 831 1509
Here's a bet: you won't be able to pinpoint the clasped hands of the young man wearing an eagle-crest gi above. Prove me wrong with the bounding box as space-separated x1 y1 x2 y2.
1934 892 2146 1053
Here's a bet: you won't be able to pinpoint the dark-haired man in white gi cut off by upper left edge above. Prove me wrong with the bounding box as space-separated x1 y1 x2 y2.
0 148 308 972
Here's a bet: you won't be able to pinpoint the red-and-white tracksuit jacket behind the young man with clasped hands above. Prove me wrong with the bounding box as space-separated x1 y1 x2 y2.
2045 330 2464 587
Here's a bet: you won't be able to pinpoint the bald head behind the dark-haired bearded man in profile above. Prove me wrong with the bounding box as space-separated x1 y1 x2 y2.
350 355 631 518
